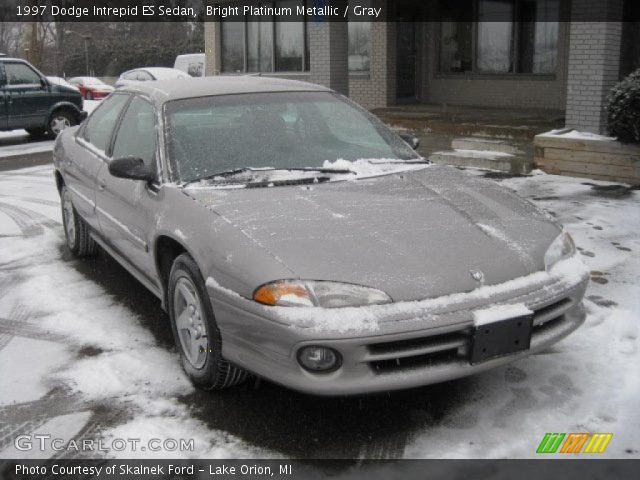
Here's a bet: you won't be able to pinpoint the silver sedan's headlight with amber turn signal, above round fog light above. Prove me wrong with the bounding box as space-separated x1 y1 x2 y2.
253 280 391 308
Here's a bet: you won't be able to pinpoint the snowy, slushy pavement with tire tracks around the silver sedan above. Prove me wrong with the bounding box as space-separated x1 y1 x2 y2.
0 166 640 458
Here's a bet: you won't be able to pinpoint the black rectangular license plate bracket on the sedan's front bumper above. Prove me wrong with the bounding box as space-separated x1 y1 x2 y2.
470 312 533 364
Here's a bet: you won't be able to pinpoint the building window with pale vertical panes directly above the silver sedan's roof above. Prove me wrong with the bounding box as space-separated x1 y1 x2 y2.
220 0 311 73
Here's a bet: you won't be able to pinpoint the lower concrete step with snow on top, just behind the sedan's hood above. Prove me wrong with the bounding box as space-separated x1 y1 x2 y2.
429 149 533 175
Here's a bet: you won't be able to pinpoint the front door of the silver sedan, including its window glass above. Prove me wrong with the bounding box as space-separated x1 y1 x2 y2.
96 95 158 282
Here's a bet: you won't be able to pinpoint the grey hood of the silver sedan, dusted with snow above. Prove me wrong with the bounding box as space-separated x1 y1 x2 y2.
185 165 560 301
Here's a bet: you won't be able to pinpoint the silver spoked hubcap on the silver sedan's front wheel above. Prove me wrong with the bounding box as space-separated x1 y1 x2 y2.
173 277 209 368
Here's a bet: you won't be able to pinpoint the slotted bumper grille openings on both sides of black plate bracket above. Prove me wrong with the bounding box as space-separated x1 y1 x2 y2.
366 298 572 375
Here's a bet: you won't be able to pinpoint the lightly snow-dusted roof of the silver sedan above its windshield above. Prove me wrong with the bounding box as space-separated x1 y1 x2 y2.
118 75 331 103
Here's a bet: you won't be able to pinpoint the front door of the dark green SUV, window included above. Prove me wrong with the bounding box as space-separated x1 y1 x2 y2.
4 61 54 129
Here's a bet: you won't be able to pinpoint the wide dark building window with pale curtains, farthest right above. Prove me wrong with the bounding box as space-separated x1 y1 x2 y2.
440 0 560 74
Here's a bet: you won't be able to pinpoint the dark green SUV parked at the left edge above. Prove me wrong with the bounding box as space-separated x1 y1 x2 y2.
0 57 86 137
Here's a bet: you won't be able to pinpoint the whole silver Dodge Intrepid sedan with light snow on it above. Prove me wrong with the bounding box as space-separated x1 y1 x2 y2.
54 76 588 395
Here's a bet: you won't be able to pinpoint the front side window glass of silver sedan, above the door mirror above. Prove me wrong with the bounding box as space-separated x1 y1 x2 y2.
112 97 156 166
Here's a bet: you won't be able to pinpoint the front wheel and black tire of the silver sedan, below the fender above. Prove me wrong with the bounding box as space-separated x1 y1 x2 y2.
167 254 248 390
